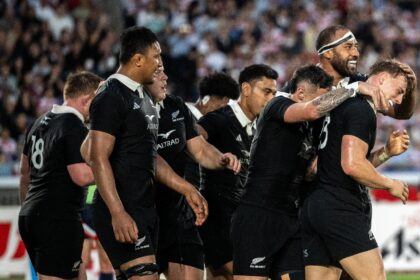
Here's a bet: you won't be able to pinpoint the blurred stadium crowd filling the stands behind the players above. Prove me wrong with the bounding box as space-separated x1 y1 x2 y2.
0 0 420 176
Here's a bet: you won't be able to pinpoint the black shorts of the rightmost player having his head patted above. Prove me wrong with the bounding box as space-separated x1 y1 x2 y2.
302 190 378 267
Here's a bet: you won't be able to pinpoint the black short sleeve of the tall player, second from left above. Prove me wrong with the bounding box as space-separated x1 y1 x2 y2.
90 86 126 136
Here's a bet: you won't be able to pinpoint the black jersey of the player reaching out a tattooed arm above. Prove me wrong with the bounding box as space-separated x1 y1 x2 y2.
242 96 312 215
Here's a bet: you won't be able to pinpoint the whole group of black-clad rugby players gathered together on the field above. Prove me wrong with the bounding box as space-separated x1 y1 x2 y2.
19 25 417 280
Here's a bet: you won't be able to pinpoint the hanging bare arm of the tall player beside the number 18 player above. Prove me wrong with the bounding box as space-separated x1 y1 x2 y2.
88 130 138 243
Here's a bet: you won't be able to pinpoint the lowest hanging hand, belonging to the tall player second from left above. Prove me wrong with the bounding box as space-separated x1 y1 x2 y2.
112 210 139 243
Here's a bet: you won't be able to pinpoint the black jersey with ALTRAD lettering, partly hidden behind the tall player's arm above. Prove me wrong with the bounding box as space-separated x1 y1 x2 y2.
156 95 198 225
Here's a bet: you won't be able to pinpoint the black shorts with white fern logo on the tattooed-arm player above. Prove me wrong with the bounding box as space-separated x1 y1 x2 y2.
232 204 303 277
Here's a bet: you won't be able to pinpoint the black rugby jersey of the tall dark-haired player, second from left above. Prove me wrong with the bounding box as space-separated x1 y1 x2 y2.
90 76 158 211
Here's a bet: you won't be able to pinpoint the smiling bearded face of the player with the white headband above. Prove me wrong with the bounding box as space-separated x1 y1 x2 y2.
331 30 359 77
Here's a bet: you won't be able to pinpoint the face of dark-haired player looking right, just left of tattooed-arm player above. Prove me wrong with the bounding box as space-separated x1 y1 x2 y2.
247 77 277 116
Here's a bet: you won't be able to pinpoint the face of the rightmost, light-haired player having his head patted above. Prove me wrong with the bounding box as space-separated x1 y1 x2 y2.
379 73 407 104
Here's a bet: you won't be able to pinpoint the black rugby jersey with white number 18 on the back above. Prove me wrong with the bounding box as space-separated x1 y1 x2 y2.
19 105 88 219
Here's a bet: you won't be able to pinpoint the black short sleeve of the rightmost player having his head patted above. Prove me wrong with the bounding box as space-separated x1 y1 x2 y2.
343 98 376 145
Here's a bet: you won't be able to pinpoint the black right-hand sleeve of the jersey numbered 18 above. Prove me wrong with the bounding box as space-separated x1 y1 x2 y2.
62 125 87 165
